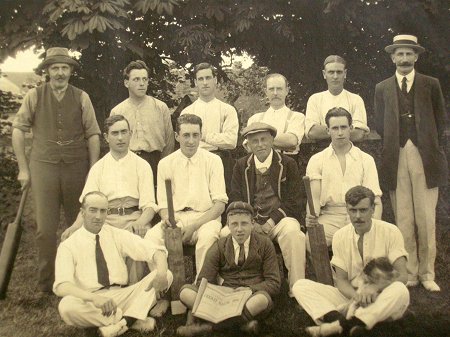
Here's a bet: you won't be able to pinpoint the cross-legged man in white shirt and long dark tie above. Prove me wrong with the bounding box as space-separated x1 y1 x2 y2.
53 191 172 337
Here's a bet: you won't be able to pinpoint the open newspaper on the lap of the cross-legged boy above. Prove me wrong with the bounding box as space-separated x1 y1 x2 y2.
192 278 252 323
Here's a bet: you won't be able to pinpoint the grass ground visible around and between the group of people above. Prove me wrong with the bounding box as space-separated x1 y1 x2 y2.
0 189 450 337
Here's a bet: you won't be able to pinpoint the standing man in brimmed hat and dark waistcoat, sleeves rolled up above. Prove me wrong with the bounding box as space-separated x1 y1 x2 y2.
12 47 100 293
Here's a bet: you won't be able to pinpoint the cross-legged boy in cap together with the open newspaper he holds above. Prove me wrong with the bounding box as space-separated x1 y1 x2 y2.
177 201 281 336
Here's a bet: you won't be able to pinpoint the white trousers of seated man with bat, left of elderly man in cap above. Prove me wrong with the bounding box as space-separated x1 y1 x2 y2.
145 211 222 274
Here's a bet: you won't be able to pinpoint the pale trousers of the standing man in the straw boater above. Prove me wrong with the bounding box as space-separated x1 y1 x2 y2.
390 140 439 281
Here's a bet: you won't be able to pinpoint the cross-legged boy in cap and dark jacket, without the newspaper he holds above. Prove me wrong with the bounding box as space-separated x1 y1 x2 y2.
177 201 281 336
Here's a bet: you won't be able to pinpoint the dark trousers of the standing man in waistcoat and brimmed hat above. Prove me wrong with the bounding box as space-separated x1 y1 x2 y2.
30 160 89 291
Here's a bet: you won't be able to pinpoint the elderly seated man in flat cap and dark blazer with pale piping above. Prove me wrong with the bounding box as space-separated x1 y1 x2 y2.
229 122 305 289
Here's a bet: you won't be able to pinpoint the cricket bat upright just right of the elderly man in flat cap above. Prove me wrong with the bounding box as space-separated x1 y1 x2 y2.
303 176 334 286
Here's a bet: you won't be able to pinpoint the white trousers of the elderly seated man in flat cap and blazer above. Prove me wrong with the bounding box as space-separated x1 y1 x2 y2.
220 217 306 289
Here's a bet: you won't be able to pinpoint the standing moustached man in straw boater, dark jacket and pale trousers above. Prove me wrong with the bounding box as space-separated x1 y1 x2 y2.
374 35 448 291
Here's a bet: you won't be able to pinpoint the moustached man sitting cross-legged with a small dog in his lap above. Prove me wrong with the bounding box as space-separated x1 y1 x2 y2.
292 186 409 336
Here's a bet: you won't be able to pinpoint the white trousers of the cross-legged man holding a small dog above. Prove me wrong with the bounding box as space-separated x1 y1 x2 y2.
292 279 409 329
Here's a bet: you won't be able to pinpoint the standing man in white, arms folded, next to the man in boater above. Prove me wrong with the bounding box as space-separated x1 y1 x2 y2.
305 55 369 141
